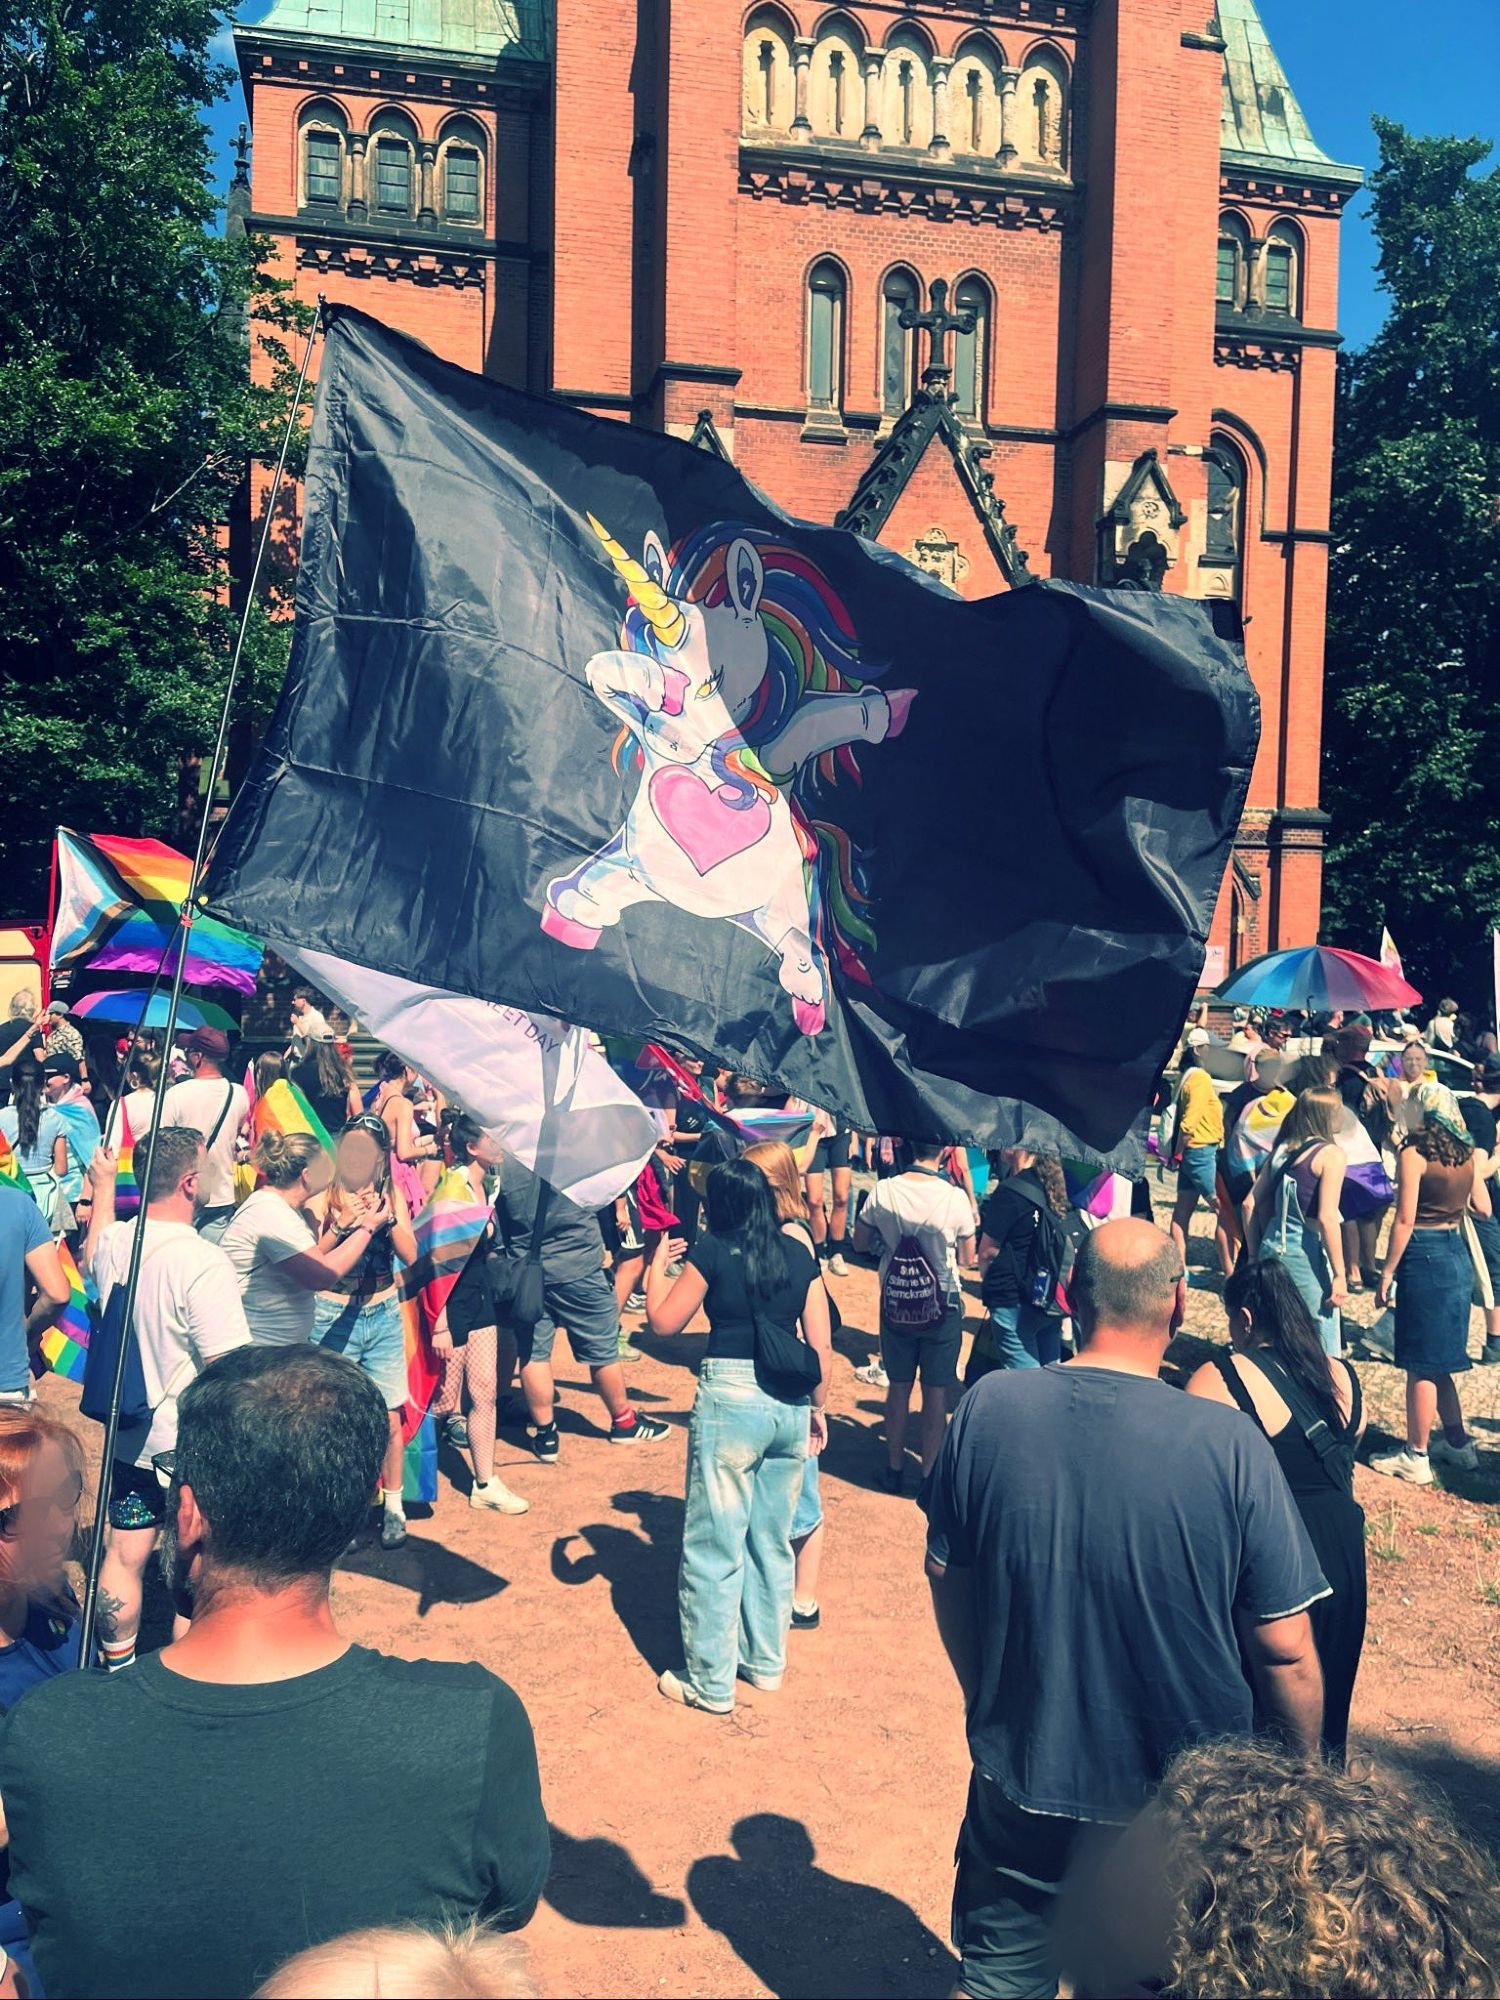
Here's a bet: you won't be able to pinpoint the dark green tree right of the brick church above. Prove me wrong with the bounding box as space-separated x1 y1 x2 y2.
1326 120 1500 1014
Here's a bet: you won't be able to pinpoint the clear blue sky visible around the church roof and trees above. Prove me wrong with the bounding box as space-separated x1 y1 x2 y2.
212 0 1500 346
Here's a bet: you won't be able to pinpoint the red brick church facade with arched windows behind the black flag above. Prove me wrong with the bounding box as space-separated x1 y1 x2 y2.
236 0 1360 982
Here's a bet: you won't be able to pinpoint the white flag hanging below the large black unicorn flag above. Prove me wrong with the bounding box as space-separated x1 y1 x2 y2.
278 946 656 1208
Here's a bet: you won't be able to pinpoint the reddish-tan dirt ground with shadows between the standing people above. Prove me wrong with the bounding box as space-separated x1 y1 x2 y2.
46 1198 1500 2000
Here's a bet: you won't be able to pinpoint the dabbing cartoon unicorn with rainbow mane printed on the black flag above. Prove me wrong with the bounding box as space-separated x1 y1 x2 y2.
542 514 916 1034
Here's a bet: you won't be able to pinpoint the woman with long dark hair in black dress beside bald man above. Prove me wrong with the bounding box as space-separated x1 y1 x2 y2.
1188 1260 1366 1764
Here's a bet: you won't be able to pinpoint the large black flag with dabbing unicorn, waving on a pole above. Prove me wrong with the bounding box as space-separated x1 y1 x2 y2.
208 308 1256 1162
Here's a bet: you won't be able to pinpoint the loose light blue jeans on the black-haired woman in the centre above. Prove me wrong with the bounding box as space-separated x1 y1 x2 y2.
678 1362 808 1708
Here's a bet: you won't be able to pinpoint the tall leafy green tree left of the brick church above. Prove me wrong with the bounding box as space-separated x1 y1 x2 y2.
0 0 304 918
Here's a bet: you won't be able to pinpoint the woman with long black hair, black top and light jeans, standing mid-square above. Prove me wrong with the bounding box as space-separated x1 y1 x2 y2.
646 1160 830 1714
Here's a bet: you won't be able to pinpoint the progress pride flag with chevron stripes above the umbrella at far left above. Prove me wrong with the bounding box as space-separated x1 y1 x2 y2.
50 826 264 994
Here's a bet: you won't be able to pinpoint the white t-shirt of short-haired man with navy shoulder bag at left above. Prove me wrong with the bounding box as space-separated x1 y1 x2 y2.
88 1218 250 1466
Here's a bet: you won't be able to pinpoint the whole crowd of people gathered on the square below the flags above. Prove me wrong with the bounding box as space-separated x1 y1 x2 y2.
0 976 1500 2000
